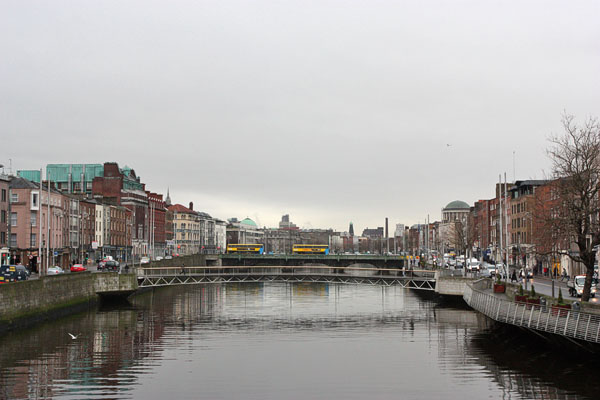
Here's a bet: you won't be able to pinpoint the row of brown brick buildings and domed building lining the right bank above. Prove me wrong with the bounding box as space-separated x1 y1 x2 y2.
403 180 584 275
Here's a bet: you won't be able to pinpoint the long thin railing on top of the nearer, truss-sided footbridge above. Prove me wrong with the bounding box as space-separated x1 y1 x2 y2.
138 265 435 279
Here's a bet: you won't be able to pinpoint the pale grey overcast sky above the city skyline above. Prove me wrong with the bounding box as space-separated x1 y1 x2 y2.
0 0 600 232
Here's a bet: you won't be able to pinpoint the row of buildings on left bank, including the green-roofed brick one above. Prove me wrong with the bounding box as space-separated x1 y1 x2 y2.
0 162 226 271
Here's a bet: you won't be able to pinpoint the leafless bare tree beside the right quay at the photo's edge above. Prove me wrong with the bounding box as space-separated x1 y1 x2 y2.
546 115 600 301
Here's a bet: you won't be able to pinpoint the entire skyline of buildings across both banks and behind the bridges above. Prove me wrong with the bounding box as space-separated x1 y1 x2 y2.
0 162 577 272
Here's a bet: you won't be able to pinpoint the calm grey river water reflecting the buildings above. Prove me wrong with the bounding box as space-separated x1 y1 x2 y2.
0 283 600 400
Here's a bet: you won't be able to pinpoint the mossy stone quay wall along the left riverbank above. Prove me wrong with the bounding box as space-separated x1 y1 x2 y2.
0 272 138 332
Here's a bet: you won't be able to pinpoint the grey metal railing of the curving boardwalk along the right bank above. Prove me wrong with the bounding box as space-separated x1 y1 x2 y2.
463 280 600 343
